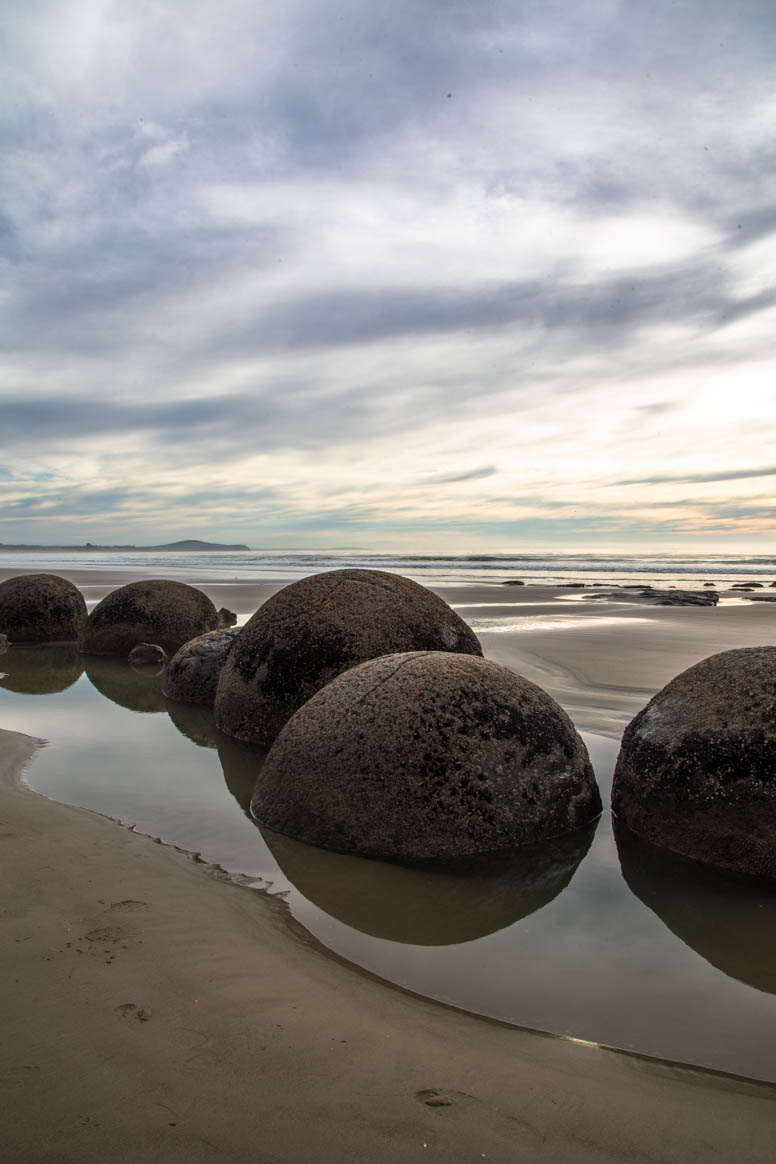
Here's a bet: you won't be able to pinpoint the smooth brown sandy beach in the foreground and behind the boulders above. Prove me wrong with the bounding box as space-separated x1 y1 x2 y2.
0 572 776 1164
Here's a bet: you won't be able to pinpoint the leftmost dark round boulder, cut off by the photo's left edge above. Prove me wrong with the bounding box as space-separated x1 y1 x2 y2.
0 574 86 643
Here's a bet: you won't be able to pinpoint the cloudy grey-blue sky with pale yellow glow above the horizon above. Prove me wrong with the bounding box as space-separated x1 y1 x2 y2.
0 0 776 552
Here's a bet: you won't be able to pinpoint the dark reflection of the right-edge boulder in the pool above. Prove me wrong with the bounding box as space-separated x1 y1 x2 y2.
614 819 776 994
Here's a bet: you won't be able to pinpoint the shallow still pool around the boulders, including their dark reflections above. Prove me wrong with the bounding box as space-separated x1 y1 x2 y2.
0 647 776 1081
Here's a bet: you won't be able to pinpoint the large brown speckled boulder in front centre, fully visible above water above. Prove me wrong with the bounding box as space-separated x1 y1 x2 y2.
251 652 600 861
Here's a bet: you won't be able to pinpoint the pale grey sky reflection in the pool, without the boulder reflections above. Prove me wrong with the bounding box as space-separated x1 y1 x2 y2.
0 668 776 1080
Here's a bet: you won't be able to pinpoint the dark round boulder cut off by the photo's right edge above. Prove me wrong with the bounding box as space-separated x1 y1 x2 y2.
612 646 776 878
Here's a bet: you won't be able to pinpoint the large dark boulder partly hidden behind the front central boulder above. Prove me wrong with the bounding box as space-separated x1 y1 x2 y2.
215 569 482 746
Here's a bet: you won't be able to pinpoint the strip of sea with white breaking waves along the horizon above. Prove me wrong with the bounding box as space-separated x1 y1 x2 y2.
0 547 776 589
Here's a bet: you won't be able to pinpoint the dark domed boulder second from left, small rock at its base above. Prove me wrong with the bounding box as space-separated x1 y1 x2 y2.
80 579 218 659
